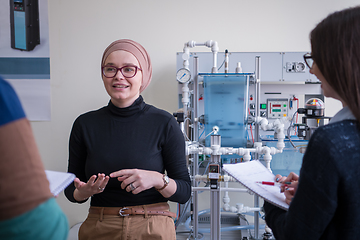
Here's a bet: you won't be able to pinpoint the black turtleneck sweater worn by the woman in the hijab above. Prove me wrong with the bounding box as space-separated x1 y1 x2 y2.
65 96 191 207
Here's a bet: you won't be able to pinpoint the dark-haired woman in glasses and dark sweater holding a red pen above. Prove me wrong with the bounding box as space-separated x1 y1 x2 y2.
264 7 360 240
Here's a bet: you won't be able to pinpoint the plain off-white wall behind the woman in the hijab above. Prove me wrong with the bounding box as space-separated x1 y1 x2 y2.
32 0 358 226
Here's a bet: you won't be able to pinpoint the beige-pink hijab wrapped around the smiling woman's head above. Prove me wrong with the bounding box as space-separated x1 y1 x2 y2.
101 39 152 93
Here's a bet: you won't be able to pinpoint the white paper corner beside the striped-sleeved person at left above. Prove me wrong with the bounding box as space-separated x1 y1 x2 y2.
45 170 75 196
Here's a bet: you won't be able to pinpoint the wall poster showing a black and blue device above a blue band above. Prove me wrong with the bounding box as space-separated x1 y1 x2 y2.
0 0 51 121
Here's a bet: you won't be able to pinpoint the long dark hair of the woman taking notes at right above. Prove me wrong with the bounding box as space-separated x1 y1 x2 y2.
310 6 360 122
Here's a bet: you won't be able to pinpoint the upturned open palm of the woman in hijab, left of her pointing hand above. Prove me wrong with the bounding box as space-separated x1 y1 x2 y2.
74 173 110 202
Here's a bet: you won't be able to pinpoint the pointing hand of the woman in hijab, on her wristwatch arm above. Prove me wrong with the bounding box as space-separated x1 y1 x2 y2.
110 169 164 194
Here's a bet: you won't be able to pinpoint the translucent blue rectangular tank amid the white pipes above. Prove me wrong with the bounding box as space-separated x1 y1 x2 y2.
200 73 250 147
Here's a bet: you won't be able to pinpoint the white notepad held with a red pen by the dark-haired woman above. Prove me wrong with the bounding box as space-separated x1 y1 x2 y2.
223 160 289 210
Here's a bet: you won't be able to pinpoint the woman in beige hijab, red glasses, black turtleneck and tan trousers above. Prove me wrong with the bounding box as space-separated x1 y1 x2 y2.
65 39 191 240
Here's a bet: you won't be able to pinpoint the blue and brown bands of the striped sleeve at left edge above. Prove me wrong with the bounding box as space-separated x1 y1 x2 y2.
0 78 52 221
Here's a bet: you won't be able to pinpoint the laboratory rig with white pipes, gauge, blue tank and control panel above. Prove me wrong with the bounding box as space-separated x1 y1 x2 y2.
174 40 321 240
